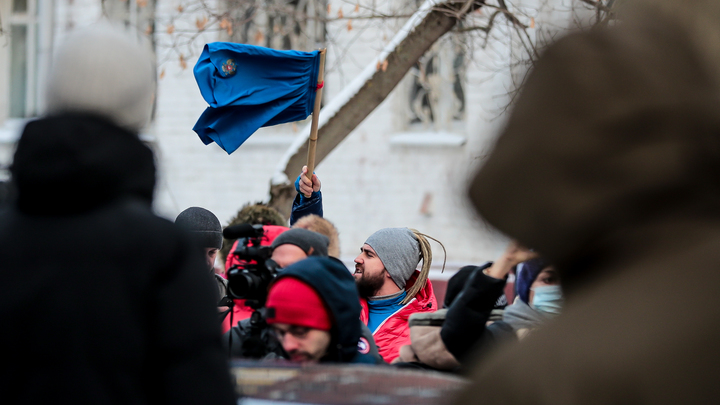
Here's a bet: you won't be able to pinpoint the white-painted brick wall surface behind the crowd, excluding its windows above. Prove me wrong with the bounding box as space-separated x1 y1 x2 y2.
4 0 580 264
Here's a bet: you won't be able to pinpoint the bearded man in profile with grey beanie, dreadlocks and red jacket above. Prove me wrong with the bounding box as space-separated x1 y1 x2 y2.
355 228 438 363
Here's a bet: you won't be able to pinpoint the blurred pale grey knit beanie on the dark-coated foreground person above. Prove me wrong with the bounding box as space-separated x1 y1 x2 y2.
46 23 155 133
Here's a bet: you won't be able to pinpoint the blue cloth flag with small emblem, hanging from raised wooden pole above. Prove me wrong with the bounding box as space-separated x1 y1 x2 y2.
193 42 320 154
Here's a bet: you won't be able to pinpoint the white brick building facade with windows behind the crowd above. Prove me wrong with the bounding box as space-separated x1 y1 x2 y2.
0 0 584 270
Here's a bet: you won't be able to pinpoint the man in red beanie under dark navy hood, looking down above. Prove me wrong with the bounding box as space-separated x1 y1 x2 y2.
266 256 382 364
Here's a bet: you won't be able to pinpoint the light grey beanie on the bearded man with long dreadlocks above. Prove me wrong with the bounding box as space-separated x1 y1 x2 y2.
365 228 420 289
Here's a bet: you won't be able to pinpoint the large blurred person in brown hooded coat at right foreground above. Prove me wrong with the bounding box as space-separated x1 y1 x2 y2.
456 1 720 404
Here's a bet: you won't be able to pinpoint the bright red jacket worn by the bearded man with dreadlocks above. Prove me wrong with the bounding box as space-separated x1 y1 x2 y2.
360 271 438 363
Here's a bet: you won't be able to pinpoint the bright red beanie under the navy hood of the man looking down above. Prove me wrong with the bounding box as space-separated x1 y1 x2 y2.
265 277 331 330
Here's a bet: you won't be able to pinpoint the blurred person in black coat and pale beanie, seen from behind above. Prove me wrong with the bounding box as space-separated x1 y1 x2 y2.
0 24 235 404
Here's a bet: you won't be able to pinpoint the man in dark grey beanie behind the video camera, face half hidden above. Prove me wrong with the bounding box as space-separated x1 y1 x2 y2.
223 228 377 358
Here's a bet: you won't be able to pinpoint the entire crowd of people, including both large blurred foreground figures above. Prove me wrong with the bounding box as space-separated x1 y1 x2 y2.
0 0 720 404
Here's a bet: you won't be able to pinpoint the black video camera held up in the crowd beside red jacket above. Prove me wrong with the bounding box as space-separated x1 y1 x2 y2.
223 224 278 309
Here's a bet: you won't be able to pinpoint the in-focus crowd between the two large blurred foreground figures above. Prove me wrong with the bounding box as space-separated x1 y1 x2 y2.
167 159 562 372
